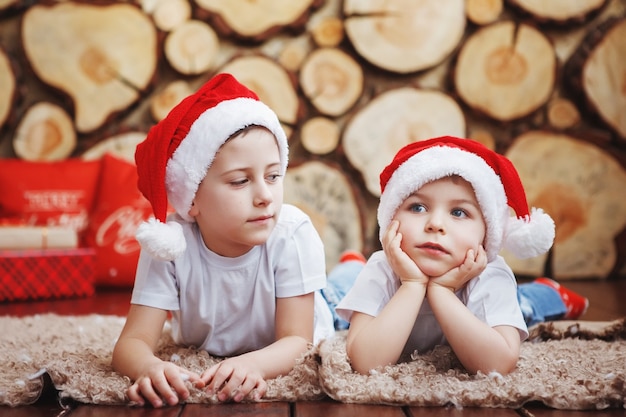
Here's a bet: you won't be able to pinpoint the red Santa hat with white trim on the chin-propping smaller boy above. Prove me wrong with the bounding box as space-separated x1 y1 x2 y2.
378 136 555 262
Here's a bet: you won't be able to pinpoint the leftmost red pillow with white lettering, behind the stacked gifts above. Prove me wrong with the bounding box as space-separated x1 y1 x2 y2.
0 159 100 237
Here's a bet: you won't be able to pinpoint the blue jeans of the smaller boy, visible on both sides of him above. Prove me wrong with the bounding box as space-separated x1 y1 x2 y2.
321 261 567 330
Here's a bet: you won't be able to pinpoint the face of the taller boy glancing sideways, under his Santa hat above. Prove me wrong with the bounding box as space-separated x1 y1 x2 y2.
189 128 283 257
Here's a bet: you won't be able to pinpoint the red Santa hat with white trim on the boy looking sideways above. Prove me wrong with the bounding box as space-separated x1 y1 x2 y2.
135 74 289 260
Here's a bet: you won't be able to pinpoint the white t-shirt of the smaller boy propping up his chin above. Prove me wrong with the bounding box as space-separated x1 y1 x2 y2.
336 251 528 355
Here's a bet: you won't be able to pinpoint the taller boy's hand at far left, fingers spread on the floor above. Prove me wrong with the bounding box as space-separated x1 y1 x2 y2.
127 360 200 408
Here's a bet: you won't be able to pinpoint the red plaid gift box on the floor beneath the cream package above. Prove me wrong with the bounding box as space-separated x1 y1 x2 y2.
0 248 95 301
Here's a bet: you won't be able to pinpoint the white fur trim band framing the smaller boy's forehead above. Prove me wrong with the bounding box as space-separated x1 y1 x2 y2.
378 146 509 262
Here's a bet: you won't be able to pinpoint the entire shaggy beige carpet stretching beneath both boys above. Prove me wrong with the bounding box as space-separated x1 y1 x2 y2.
0 314 626 410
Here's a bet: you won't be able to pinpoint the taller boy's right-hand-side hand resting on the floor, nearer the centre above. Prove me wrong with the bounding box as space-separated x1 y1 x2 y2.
200 356 267 402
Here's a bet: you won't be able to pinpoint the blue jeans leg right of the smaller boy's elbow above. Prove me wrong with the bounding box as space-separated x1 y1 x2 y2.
517 282 567 326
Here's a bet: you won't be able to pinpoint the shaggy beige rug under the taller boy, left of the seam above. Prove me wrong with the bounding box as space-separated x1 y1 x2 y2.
0 314 325 406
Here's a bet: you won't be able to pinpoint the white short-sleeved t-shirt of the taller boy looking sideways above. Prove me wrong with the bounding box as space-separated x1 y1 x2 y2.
131 204 334 356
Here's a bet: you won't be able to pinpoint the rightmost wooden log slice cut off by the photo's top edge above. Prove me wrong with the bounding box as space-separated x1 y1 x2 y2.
507 0 608 24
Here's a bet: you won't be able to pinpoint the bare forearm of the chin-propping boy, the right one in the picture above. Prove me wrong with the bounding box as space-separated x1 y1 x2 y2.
427 283 520 374
